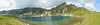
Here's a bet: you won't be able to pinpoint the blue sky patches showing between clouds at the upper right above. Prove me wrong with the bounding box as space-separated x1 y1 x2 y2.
74 0 100 12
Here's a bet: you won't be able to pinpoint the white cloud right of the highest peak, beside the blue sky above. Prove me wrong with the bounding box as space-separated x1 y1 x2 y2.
66 0 96 10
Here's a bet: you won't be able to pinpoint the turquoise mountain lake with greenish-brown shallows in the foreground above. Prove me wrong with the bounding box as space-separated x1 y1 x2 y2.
19 16 82 25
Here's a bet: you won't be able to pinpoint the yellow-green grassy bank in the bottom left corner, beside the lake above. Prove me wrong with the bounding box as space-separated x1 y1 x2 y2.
0 16 26 25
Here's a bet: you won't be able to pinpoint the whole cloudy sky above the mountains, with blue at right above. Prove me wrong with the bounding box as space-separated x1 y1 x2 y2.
0 0 100 12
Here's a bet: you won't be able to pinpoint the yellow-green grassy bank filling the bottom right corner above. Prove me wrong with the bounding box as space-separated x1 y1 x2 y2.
76 12 100 25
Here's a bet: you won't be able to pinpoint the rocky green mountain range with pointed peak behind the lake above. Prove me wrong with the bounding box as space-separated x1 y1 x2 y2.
0 2 99 17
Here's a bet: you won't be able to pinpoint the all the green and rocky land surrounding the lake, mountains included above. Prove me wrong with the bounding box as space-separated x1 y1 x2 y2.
0 2 100 25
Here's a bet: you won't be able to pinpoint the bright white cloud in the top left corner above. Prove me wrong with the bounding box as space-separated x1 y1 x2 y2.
0 0 16 11
